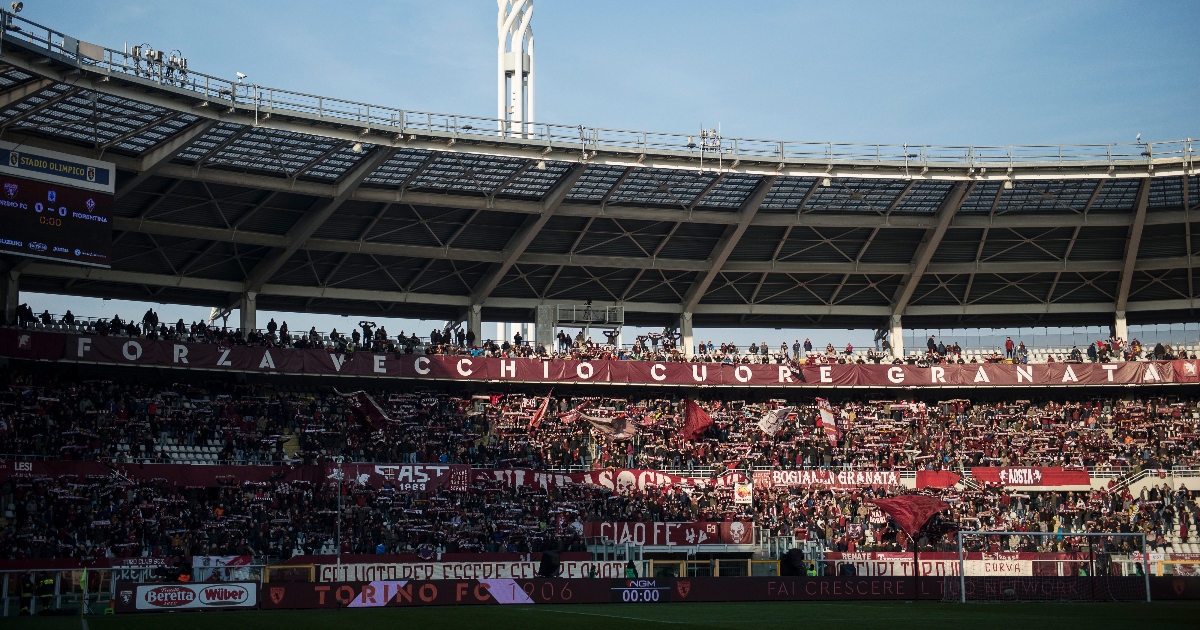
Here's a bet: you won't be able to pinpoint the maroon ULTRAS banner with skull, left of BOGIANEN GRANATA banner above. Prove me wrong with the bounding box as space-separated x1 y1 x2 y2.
470 468 748 493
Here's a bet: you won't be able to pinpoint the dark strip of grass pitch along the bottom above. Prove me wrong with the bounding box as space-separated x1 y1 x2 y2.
2 601 1200 630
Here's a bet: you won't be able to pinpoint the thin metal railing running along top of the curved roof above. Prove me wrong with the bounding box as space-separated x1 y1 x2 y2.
0 11 1195 172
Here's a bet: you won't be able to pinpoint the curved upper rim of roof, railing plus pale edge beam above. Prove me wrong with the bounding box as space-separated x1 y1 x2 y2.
0 11 1195 181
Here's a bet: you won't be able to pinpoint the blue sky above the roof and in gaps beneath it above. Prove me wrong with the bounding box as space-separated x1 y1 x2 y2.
22 0 1200 346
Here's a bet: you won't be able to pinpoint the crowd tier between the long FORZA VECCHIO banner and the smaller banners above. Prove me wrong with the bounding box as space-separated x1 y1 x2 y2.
0 373 1200 474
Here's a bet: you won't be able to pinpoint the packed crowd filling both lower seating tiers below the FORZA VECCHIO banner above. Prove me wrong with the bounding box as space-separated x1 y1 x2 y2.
0 373 1200 559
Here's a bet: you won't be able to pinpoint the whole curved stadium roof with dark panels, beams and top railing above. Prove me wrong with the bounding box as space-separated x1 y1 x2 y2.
0 13 1200 328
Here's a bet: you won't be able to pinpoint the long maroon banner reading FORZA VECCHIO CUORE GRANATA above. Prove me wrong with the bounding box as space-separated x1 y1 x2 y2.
0 329 1200 388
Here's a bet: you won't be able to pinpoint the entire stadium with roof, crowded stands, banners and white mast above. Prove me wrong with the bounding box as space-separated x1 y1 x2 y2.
0 0 1200 630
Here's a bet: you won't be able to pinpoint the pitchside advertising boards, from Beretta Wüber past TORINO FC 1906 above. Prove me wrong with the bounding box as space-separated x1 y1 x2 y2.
115 576 1200 613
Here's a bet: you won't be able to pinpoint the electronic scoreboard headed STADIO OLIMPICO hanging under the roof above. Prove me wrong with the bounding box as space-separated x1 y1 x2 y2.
0 143 116 266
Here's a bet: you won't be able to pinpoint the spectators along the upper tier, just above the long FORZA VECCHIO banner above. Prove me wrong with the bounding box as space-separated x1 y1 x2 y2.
7 304 1195 366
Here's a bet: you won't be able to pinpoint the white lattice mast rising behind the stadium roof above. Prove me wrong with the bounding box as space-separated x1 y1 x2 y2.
496 0 534 138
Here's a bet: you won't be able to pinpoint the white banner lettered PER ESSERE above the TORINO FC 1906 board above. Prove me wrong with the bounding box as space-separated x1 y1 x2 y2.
317 560 625 582
